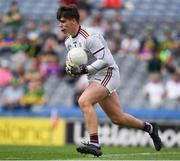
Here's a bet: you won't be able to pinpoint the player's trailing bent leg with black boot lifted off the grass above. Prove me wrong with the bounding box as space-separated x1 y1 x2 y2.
99 92 162 151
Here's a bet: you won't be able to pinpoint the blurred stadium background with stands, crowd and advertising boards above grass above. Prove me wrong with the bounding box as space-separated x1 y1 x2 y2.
0 0 180 151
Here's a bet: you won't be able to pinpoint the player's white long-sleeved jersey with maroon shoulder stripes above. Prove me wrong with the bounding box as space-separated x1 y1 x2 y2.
65 26 118 75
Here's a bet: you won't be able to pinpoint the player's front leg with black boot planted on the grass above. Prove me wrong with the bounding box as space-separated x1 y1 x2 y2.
77 82 108 156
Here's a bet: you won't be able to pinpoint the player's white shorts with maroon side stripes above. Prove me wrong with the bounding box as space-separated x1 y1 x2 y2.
89 67 120 93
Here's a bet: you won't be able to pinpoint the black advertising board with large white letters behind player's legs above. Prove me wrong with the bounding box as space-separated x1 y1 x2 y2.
66 121 180 147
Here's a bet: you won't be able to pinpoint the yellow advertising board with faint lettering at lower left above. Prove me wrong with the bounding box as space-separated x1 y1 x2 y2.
0 117 65 145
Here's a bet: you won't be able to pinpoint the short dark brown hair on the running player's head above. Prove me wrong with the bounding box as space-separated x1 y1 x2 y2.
56 4 80 22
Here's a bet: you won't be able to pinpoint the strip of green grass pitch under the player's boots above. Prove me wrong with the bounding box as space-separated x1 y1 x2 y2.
0 145 180 161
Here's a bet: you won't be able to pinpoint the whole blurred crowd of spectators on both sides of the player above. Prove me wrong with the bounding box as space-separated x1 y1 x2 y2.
0 2 180 110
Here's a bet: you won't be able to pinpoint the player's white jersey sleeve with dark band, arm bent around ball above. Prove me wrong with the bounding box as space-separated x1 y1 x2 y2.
86 35 107 73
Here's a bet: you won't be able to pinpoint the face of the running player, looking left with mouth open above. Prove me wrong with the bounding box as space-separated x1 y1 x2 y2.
59 17 75 35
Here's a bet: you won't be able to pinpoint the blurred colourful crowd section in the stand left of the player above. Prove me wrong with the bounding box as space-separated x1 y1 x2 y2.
0 2 67 110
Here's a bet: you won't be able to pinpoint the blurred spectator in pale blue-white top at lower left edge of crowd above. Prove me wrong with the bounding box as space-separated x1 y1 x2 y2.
0 79 24 110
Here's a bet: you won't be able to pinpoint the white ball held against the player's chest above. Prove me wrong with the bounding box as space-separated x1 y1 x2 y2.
67 47 88 66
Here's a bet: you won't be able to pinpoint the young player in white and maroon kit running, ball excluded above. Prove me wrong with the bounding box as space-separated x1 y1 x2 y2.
57 5 162 156
